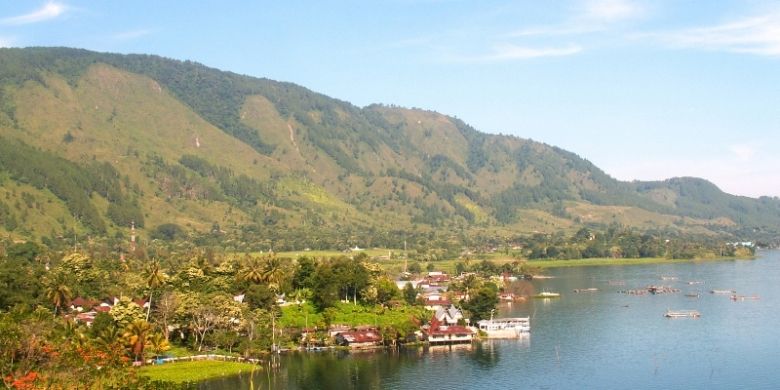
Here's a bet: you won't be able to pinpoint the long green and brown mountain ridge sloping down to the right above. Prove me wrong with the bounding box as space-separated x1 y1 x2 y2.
0 48 780 247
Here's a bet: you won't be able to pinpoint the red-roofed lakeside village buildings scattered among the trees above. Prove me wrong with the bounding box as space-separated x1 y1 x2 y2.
65 271 530 356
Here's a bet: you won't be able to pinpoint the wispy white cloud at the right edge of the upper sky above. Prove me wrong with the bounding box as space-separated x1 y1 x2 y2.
644 11 780 56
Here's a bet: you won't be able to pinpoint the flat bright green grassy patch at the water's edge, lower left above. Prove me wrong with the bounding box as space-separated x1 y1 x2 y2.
139 360 258 383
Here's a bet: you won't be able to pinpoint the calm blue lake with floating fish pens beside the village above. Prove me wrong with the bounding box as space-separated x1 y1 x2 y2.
201 251 780 389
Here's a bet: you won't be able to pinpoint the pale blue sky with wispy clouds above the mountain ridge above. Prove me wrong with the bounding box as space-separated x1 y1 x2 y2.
0 0 780 197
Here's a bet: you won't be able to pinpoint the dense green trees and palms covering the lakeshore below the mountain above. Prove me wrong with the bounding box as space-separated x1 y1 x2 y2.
0 221 753 388
